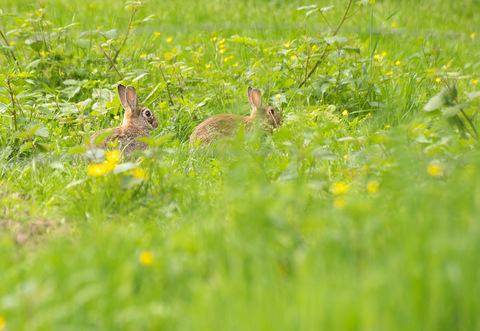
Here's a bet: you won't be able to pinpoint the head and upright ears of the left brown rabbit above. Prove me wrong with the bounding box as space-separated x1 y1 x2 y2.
118 84 158 132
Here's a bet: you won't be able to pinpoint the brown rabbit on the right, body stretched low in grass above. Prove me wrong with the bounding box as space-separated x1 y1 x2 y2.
190 86 282 145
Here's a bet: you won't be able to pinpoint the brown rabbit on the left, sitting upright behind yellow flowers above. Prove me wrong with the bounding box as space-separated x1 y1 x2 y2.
91 84 158 154
